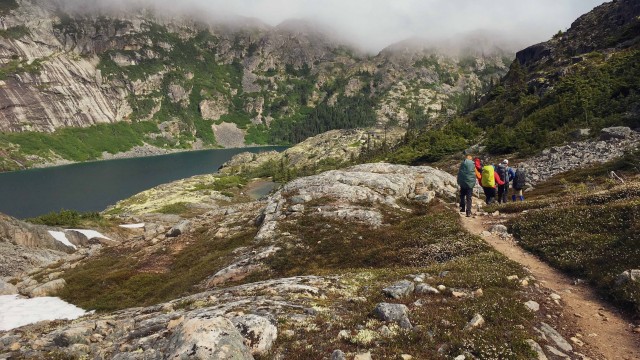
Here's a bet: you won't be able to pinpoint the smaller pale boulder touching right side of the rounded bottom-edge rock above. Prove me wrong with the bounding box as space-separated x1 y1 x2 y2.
231 315 278 355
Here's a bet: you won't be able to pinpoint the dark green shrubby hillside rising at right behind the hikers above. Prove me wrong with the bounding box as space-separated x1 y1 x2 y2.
382 0 640 163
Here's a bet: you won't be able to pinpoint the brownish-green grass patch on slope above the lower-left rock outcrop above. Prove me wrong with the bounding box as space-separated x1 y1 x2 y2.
60 229 255 311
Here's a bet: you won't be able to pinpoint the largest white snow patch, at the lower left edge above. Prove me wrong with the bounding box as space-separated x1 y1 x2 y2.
0 295 86 331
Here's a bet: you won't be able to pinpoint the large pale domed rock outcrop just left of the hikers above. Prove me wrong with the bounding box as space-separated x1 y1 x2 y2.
256 163 456 241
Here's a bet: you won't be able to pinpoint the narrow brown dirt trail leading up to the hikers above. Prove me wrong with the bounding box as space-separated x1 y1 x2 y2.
462 217 640 360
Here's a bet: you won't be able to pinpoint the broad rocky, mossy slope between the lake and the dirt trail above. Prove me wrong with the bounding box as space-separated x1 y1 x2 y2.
0 164 604 359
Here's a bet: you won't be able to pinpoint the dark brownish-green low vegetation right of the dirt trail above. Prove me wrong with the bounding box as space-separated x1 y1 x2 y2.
510 193 640 313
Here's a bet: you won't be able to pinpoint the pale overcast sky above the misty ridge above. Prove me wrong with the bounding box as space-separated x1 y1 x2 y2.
60 0 606 52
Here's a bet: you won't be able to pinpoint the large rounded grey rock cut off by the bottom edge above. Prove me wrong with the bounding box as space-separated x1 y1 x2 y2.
166 317 253 360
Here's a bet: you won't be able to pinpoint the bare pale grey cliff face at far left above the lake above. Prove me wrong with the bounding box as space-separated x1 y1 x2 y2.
0 1 130 132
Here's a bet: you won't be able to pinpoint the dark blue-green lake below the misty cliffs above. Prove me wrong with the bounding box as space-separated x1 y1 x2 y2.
0 147 285 218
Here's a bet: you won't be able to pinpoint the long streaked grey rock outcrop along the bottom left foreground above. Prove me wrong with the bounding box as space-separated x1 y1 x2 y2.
2 276 343 359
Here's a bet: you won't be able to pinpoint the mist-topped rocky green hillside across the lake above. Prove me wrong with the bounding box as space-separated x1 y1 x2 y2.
0 0 511 170
